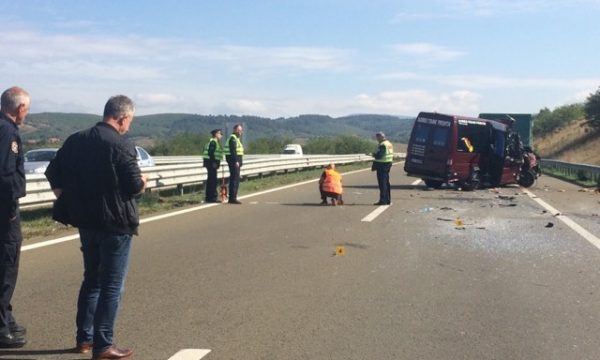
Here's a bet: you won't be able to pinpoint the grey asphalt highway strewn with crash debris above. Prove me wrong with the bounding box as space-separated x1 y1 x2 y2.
0 164 600 360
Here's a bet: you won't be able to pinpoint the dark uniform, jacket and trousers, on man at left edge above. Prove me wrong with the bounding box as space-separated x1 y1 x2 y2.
0 113 25 335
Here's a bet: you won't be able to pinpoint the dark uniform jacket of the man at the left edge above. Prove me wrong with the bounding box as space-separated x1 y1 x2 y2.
0 113 25 222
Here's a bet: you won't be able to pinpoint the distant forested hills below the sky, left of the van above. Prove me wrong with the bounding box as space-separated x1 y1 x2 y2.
21 113 414 143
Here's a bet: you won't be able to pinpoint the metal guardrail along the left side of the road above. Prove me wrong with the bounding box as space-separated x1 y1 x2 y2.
20 154 382 208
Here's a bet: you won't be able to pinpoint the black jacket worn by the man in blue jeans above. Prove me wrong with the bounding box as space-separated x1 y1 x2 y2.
46 122 144 234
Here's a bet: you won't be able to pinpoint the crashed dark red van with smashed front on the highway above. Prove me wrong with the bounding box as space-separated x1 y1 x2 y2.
404 112 537 190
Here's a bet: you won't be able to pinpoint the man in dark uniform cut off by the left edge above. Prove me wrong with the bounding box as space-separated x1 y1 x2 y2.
0 87 30 348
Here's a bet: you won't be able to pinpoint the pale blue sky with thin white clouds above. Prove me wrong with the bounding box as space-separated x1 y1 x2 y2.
0 0 600 117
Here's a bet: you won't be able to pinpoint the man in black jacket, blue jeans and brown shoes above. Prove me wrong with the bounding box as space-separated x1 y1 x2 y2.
46 95 147 360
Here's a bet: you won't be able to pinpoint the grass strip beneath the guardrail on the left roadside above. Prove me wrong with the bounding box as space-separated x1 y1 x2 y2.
21 163 370 239
